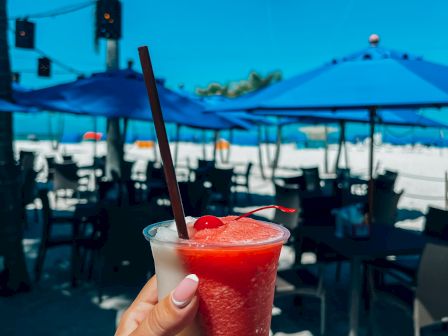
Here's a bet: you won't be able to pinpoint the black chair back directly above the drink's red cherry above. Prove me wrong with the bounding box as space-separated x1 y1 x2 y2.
207 167 233 214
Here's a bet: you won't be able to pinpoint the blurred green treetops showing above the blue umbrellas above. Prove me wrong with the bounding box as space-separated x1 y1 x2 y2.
196 71 282 98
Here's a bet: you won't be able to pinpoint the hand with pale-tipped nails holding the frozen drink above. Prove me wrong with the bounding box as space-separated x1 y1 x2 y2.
115 274 199 336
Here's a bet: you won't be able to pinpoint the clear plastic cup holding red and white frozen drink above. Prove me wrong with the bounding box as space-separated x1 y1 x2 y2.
143 221 289 336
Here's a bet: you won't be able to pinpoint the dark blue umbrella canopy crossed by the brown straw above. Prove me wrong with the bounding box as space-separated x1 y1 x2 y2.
14 69 251 129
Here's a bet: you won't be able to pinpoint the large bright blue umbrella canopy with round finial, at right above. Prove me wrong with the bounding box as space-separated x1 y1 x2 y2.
214 45 448 110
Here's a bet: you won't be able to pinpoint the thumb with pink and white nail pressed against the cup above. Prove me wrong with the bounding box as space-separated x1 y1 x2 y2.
131 274 199 336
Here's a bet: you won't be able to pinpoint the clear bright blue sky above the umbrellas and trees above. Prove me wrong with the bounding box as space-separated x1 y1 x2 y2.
8 0 448 90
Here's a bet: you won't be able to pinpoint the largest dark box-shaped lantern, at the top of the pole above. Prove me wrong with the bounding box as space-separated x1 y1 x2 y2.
95 0 121 40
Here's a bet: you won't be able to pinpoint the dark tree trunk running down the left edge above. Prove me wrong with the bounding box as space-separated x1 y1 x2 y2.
0 0 29 294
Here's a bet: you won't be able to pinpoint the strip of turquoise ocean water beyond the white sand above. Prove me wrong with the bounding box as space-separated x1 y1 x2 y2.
14 112 448 147
